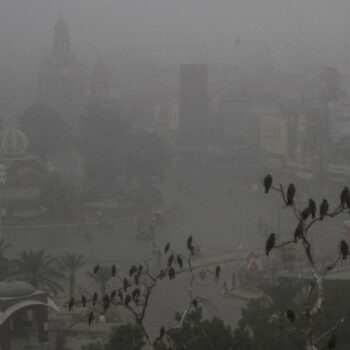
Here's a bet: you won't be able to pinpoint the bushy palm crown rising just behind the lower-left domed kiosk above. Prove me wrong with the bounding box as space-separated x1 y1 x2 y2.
15 249 63 294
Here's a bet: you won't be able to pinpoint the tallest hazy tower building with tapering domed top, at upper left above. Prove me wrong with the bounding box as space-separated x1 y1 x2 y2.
38 16 85 127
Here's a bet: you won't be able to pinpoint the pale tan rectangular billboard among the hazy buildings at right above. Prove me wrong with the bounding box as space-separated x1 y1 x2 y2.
260 115 287 155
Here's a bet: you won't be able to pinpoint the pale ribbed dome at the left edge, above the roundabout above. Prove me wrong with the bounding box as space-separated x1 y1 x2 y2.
0 128 29 156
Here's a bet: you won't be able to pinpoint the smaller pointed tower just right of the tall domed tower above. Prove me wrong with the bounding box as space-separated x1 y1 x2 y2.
90 57 109 101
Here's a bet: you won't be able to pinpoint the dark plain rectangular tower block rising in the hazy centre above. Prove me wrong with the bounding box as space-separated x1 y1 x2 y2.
179 64 208 148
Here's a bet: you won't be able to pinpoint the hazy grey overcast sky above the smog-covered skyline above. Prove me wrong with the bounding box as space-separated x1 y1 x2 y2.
0 0 350 78
